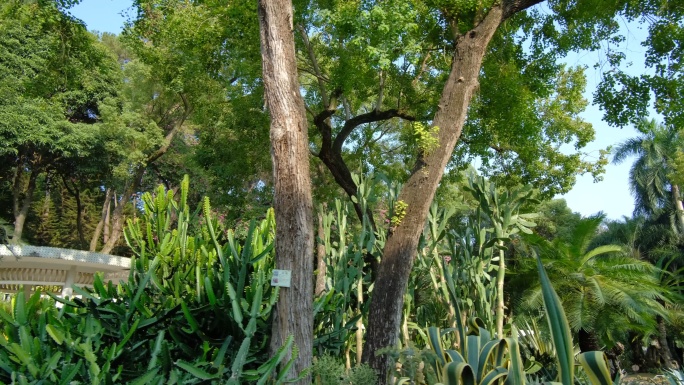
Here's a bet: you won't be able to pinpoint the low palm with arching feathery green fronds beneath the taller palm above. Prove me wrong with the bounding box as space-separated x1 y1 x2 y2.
522 214 666 351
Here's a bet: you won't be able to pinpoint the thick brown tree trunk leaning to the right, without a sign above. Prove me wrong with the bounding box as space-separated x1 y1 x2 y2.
364 5 504 384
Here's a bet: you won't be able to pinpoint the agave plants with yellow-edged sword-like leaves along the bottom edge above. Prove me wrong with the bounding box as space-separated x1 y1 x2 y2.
388 252 619 385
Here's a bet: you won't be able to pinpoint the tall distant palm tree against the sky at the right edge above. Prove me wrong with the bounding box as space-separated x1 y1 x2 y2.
613 120 684 234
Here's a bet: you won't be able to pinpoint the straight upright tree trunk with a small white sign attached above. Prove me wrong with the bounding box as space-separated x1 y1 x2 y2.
258 0 314 384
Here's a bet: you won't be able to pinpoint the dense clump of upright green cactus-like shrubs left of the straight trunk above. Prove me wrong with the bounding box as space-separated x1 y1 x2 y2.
0 178 297 384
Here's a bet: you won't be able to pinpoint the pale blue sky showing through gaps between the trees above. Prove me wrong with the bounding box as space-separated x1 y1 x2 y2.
71 0 645 219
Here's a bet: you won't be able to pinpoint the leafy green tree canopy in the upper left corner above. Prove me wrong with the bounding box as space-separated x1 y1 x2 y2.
0 0 120 242
